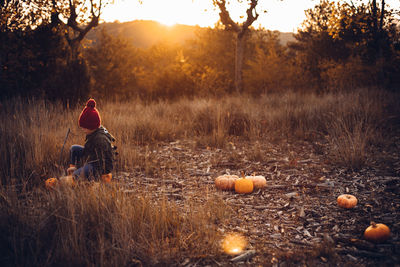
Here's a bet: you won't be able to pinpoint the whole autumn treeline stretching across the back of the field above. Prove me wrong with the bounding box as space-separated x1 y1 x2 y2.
0 1 400 102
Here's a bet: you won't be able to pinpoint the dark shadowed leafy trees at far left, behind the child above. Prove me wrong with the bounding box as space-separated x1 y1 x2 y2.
0 0 104 103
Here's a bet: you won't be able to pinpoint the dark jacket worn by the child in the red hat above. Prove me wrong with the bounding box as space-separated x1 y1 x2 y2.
83 126 115 176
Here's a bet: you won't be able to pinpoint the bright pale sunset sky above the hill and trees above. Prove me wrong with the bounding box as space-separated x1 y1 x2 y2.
102 0 399 32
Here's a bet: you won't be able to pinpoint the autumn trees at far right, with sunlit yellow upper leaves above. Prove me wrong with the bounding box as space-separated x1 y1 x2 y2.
290 0 400 91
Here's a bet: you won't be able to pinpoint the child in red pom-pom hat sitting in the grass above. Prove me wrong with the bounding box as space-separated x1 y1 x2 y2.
67 99 115 183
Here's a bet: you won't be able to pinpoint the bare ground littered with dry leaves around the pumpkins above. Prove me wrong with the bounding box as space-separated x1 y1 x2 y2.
117 137 400 266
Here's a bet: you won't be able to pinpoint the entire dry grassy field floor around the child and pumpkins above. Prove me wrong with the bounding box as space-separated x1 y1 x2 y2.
0 90 400 266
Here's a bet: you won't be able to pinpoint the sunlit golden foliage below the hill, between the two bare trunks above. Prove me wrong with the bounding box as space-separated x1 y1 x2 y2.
85 26 238 100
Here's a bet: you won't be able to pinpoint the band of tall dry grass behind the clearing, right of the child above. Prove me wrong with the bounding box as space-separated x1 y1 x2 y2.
99 89 398 168
